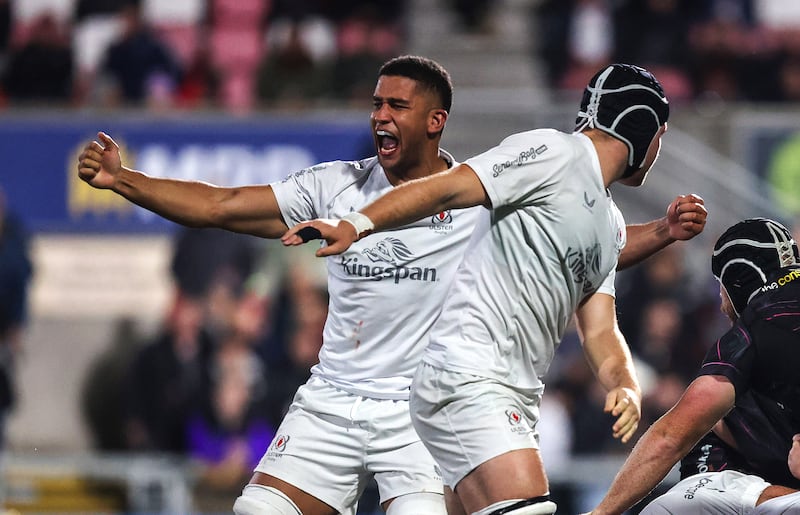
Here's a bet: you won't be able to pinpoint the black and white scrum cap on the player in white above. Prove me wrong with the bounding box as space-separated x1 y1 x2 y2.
575 64 669 177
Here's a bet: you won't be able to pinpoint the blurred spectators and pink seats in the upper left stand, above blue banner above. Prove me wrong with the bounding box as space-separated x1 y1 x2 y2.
0 0 406 111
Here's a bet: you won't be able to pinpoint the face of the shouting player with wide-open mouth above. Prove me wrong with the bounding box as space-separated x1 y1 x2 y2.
370 75 435 175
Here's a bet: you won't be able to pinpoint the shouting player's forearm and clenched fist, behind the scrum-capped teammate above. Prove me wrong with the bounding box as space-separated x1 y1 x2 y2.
617 193 708 270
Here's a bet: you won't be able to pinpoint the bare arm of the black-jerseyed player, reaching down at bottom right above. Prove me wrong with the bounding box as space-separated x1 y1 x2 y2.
592 376 735 515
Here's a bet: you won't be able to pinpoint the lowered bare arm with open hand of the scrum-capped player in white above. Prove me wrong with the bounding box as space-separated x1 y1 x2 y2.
576 293 642 442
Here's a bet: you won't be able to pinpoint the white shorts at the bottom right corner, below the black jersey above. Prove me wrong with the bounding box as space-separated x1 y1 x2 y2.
641 470 779 515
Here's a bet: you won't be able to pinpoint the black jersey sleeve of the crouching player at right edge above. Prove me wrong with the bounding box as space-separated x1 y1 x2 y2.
697 322 755 397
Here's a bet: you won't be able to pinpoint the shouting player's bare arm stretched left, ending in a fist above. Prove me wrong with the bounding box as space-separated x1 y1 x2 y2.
78 132 287 238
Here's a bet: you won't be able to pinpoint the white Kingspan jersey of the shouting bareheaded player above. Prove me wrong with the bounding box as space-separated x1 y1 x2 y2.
272 151 480 399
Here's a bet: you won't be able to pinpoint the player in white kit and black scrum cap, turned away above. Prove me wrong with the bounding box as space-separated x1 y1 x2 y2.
283 64 702 515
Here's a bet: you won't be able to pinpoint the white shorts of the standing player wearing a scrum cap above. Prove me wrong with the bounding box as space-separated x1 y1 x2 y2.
411 362 543 488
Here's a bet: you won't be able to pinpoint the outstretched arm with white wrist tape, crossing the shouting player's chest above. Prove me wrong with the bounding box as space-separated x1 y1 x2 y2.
281 164 489 257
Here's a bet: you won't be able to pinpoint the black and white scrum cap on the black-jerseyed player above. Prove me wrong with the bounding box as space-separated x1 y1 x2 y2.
711 218 800 314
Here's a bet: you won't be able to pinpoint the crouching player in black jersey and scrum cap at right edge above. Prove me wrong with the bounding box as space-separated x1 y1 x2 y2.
592 218 800 515
